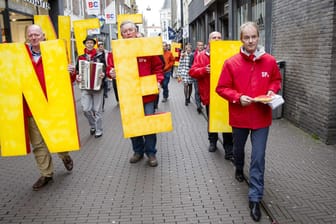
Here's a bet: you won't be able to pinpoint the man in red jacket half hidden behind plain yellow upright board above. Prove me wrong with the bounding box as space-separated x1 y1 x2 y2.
189 31 233 160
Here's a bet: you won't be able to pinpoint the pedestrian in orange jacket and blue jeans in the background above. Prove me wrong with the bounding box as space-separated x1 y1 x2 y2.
162 42 175 103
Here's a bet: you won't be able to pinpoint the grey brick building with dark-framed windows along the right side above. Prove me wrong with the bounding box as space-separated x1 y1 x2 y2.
188 0 336 144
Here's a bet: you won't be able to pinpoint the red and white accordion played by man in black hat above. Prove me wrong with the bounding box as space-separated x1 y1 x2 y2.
78 60 104 90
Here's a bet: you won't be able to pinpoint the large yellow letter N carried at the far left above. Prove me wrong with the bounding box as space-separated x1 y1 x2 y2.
0 40 79 156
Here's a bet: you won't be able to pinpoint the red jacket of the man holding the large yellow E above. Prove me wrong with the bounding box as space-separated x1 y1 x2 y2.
106 52 164 103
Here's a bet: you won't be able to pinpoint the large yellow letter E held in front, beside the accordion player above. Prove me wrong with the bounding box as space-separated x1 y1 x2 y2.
112 37 172 138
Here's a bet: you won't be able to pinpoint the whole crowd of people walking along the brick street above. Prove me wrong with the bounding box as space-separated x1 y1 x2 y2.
25 21 281 221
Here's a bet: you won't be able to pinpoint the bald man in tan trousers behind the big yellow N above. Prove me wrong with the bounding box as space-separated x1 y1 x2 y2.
24 25 73 191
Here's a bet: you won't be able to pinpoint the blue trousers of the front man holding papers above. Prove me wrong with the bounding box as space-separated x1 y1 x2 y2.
232 127 269 202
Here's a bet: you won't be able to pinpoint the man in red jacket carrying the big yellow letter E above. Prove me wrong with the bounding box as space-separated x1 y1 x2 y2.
107 21 163 167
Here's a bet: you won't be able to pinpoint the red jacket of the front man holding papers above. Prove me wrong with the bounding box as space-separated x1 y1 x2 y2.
216 50 281 129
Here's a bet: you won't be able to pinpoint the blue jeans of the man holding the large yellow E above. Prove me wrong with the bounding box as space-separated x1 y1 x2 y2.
131 101 156 156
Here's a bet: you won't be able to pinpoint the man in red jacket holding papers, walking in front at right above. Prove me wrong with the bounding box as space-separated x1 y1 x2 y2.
216 22 281 221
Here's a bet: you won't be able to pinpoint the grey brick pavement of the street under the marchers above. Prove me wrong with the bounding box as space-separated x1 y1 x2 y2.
0 80 336 224
